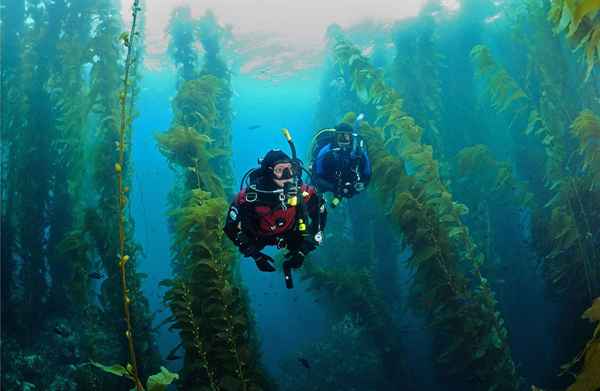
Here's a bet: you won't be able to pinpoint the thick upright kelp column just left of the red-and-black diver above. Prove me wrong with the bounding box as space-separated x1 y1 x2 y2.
162 16 267 391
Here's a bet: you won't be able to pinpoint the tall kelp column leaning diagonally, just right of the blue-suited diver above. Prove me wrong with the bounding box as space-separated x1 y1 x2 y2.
335 35 519 390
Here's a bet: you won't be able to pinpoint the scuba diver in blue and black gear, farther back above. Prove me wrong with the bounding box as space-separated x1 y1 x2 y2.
310 114 371 207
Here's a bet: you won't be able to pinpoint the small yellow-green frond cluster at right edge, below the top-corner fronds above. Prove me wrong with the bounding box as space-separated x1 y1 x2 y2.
571 110 600 186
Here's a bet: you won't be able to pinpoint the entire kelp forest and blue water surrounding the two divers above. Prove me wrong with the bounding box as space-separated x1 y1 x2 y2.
0 0 600 391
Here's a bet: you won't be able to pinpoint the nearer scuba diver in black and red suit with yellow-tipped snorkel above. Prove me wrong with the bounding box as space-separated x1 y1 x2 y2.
223 129 327 289
